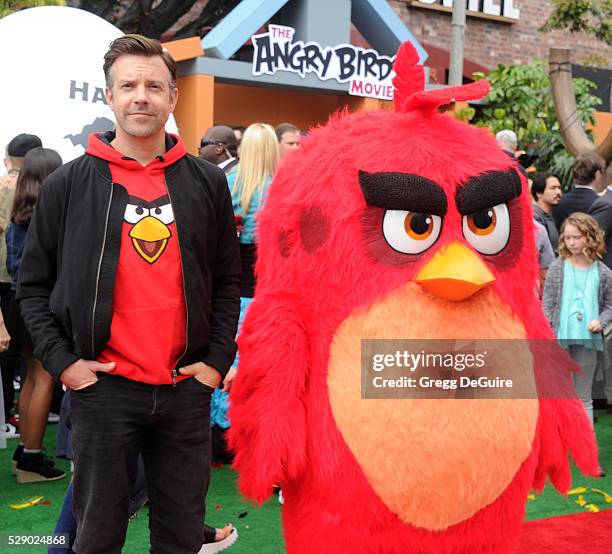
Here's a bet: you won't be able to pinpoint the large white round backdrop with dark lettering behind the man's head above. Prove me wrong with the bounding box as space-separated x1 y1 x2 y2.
0 6 177 162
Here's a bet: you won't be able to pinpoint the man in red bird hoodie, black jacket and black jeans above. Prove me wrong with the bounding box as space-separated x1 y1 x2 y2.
17 35 240 554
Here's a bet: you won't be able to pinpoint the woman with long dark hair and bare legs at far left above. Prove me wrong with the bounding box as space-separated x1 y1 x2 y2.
6 148 64 483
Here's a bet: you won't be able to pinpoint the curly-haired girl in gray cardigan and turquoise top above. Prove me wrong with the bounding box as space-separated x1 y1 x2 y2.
542 212 612 423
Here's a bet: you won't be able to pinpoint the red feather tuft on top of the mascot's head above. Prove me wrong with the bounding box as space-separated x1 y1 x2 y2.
393 42 490 112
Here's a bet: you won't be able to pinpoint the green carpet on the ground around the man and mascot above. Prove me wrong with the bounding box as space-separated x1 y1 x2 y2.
0 412 612 554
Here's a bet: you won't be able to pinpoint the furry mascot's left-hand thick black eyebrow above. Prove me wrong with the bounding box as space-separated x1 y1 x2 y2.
359 170 448 216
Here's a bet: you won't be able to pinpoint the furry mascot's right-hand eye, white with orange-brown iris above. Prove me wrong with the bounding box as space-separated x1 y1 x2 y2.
463 204 510 256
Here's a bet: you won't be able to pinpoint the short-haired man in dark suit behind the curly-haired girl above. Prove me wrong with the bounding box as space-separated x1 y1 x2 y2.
553 152 606 230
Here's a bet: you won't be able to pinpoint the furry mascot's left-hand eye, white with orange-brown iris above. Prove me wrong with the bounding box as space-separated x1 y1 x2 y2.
383 210 442 254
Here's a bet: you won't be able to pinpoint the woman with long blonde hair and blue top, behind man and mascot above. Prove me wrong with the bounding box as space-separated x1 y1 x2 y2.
210 123 279 464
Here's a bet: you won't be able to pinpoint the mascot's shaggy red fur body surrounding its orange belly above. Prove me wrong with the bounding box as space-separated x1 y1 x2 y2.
229 44 598 554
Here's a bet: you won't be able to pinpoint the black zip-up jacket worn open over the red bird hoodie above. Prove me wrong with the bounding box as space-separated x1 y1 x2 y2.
17 136 240 379
